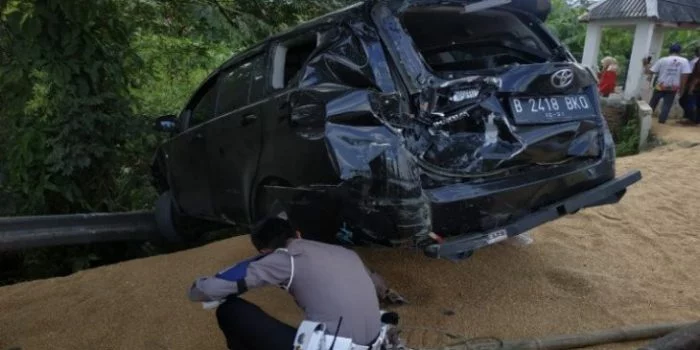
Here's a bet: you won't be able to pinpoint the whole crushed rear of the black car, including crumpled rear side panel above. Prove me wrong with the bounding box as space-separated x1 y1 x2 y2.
275 0 641 257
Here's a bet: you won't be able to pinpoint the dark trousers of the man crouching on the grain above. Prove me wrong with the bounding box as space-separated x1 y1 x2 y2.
216 297 297 350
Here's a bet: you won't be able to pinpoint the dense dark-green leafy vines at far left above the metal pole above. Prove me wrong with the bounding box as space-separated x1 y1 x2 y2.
0 0 140 213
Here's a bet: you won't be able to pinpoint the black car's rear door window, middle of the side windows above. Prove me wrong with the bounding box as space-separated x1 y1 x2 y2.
216 54 265 116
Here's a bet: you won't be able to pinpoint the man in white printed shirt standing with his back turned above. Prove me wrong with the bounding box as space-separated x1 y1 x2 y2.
644 43 691 124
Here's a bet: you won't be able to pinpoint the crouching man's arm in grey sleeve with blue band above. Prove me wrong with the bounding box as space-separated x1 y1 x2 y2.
188 252 292 302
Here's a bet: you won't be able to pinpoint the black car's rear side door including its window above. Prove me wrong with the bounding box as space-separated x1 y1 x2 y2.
207 51 266 222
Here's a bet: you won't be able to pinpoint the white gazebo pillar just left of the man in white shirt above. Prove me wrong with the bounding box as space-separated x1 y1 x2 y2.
624 21 663 99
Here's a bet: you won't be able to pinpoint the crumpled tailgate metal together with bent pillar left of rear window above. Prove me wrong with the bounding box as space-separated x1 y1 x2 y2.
373 0 602 177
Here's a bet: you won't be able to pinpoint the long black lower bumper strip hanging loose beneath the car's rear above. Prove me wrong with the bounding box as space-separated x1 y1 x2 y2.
424 170 642 258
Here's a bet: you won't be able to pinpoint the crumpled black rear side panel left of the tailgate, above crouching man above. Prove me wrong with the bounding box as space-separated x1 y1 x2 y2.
277 15 430 244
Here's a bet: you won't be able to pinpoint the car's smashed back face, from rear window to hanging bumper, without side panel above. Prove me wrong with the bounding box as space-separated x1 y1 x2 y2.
375 1 641 256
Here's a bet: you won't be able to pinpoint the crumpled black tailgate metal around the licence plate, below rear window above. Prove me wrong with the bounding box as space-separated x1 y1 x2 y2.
405 68 602 177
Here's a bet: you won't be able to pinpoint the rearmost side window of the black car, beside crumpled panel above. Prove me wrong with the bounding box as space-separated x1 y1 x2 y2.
272 31 318 89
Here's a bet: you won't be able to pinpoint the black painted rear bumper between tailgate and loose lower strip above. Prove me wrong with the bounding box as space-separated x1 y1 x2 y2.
424 157 615 237
